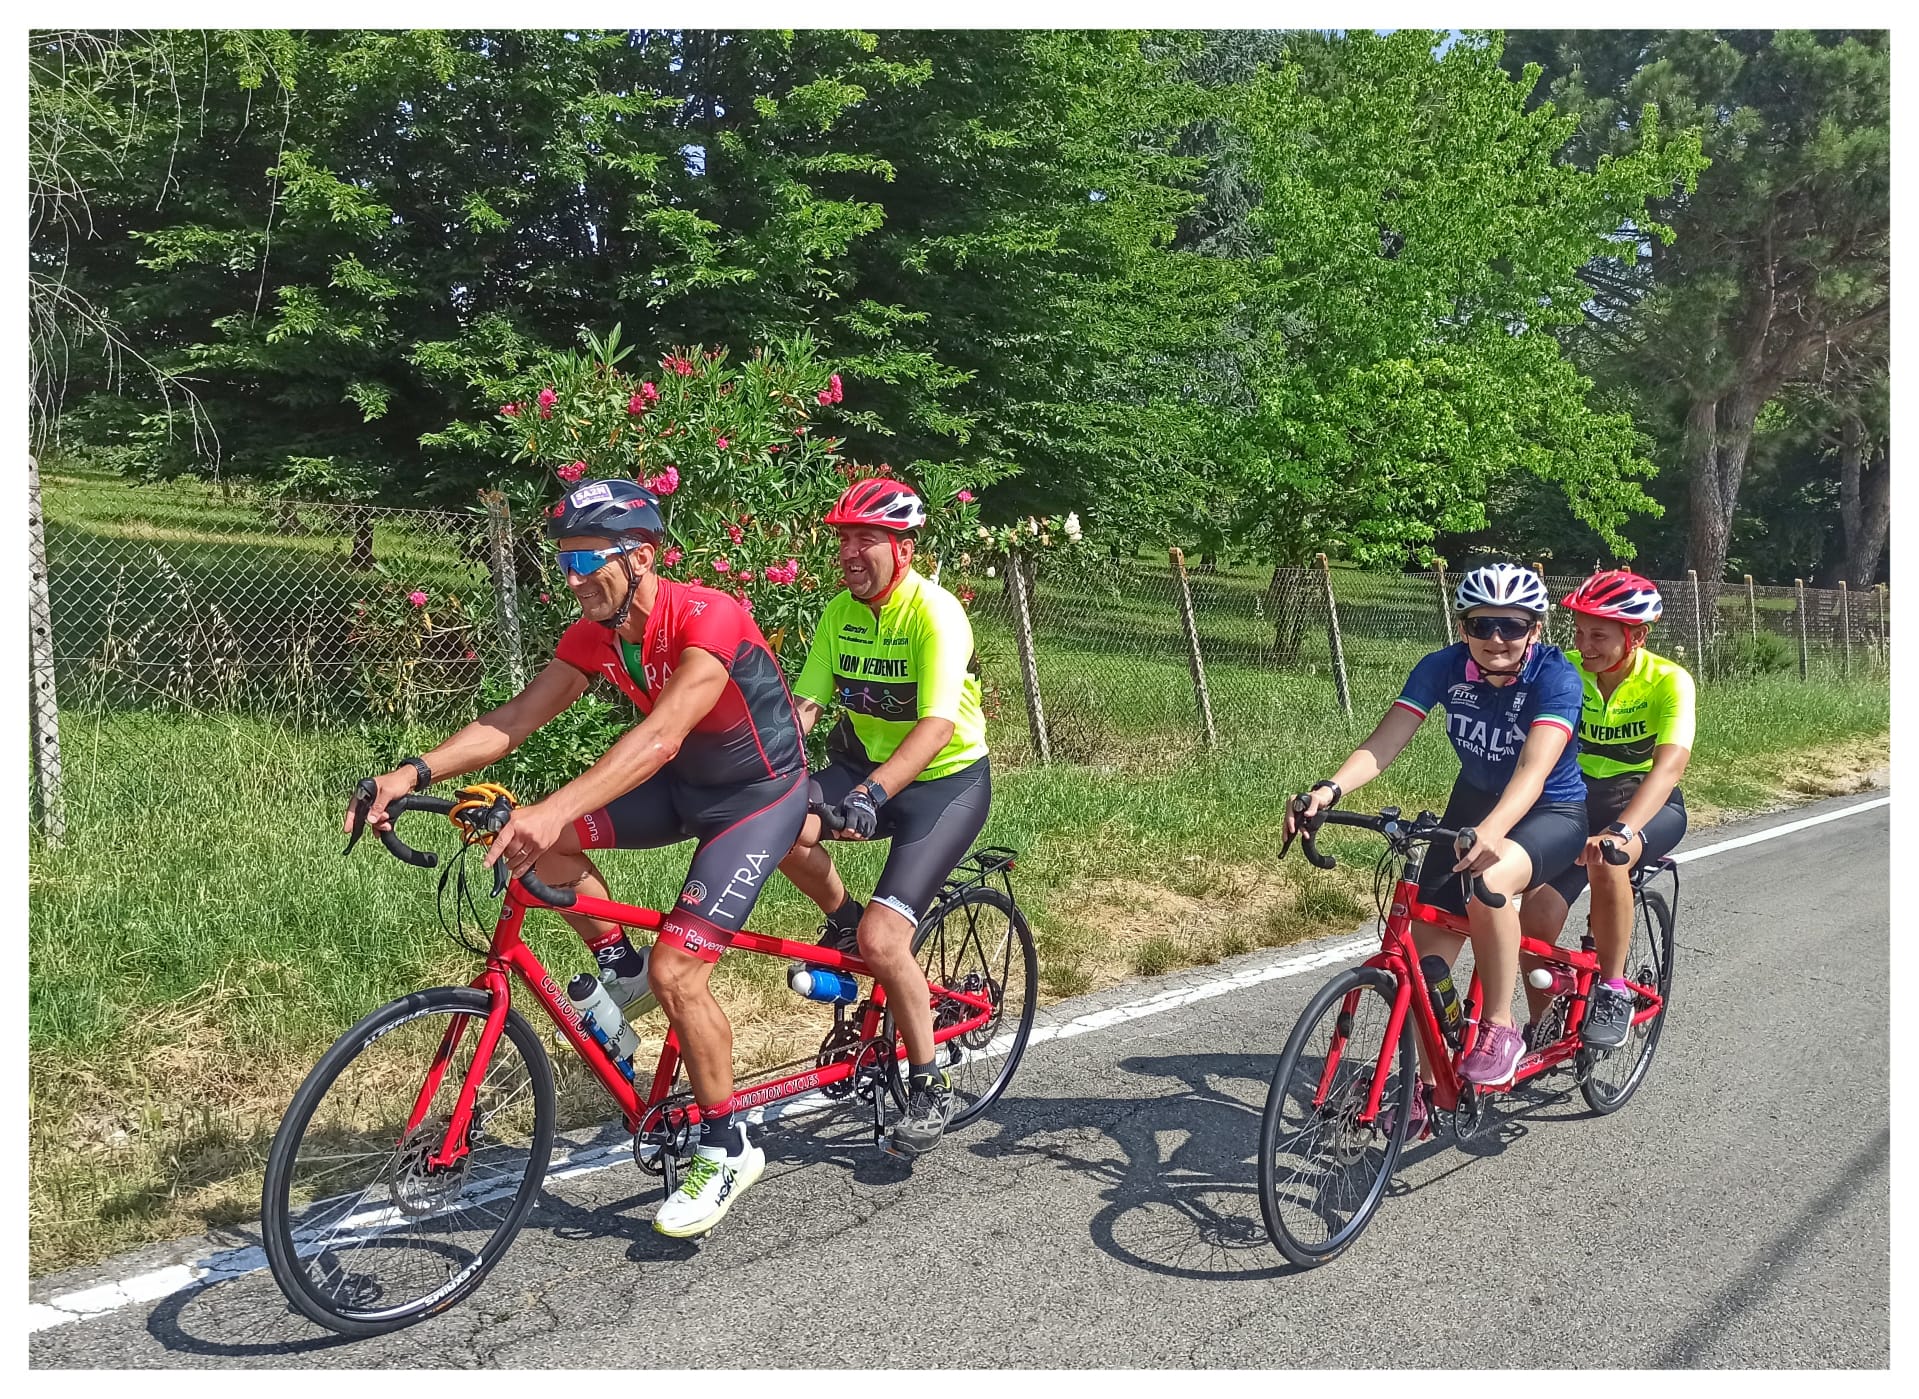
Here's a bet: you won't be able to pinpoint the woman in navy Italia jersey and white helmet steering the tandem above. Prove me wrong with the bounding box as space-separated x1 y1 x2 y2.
1286 564 1585 1136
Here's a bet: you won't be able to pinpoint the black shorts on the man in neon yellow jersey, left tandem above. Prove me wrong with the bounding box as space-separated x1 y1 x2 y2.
814 752 992 927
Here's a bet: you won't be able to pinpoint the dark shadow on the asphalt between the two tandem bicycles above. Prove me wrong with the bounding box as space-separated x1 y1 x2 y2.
967 1054 1295 1282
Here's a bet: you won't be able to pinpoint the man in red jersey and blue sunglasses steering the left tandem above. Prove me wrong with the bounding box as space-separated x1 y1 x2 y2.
351 480 806 1238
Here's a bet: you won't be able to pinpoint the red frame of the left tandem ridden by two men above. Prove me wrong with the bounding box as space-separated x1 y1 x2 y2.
407 879 992 1169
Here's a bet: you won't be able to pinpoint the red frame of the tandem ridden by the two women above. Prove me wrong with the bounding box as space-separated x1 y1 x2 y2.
1315 848 1664 1123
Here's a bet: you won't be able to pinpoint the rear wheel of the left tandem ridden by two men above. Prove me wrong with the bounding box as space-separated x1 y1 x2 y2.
887 885 1040 1128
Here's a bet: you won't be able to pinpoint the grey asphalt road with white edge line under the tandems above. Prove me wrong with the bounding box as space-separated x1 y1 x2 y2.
29 796 1890 1368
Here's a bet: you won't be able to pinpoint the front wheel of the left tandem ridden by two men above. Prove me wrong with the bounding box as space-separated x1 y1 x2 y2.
261 986 555 1336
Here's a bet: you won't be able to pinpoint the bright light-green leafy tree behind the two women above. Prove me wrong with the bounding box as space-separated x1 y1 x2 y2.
1220 31 1698 562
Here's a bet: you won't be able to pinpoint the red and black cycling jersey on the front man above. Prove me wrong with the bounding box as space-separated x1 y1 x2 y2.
555 578 806 787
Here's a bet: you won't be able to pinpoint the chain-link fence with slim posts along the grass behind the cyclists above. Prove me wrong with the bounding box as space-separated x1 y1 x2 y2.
31 472 1890 839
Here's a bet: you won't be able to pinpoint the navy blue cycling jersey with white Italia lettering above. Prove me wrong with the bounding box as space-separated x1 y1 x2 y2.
1393 641 1585 802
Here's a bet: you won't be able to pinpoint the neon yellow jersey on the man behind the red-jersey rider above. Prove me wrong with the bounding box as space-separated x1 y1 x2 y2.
793 568 986 781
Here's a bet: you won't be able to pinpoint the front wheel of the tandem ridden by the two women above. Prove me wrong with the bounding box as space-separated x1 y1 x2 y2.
1259 967 1418 1269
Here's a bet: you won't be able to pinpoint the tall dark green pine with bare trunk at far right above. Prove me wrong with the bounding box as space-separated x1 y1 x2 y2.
1504 31 1890 581
